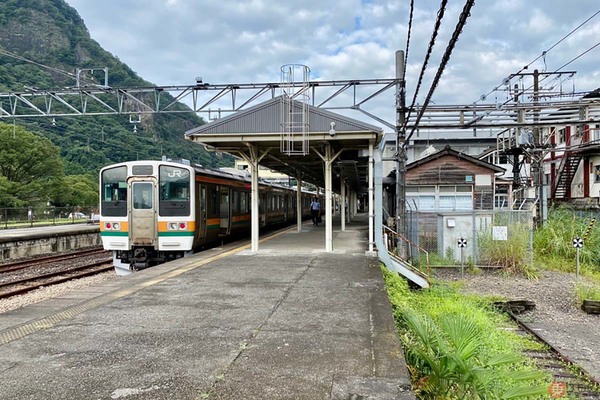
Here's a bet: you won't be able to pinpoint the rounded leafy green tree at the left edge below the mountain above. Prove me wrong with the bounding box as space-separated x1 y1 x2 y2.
0 123 64 207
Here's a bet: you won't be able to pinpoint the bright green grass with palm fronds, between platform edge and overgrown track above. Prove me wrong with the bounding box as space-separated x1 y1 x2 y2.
382 267 549 400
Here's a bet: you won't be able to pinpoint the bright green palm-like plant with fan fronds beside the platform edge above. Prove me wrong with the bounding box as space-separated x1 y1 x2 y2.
403 310 547 399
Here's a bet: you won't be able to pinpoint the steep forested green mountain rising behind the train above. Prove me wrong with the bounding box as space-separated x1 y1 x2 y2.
0 0 233 174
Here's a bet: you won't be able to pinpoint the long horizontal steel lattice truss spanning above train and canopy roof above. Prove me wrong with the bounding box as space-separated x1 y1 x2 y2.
0 78 398 119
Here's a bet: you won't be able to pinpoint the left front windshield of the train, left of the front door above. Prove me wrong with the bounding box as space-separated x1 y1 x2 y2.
101 166 127 217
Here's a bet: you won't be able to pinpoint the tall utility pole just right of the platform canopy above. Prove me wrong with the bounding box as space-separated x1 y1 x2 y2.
396 50 407 258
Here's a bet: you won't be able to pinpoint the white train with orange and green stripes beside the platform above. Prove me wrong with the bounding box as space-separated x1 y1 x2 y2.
100 161 314 275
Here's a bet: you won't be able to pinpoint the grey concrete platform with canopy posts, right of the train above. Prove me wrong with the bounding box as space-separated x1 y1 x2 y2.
0 215 414 399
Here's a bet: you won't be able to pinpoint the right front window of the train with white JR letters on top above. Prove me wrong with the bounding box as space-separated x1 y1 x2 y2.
158 165 190 217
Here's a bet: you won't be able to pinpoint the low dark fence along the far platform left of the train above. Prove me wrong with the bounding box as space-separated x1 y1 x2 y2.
0 207 99 229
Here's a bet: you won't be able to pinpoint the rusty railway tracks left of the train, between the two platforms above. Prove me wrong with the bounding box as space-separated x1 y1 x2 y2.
0 248 113 299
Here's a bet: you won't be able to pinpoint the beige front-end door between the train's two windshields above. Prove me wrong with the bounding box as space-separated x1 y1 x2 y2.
129 178 157 246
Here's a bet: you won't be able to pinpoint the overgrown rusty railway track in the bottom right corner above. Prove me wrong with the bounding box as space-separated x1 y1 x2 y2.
501 303 600 400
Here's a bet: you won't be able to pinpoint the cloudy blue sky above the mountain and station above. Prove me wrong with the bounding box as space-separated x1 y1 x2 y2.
66 0 600 131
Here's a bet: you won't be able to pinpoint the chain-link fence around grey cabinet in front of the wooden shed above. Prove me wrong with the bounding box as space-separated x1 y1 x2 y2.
407 210 533 267
